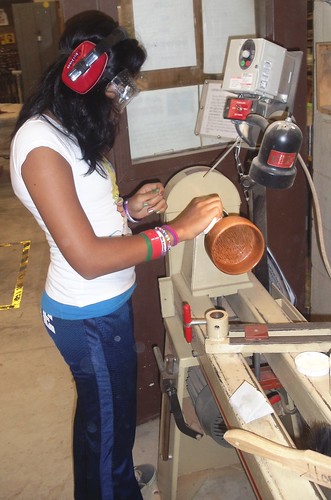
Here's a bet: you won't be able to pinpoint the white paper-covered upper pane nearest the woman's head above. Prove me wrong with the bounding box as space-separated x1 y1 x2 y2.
132 0 197 71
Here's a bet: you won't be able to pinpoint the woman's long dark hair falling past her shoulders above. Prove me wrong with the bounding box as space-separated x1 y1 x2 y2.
14 10 146 175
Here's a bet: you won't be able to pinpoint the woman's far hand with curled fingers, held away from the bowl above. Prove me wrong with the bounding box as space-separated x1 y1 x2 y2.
120 182 168 219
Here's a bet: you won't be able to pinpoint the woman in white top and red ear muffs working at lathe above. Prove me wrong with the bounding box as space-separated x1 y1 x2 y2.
11 11 222 500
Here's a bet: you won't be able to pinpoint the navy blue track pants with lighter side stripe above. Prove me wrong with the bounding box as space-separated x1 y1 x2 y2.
42 301 142 500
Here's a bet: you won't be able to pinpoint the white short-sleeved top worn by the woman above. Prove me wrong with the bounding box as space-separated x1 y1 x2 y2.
10 117 135 307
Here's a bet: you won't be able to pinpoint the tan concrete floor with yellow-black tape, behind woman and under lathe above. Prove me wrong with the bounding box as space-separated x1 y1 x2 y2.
0 155 255 500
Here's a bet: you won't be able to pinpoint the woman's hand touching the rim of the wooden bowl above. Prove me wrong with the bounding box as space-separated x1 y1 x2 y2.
169 194 223 241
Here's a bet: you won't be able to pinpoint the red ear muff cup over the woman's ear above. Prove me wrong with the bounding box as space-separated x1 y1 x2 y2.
62 40 108 94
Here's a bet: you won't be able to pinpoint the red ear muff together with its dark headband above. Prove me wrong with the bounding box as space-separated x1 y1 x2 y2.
62 28 127 94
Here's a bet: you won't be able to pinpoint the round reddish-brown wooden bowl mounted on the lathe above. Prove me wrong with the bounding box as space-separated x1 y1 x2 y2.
205 215 265 274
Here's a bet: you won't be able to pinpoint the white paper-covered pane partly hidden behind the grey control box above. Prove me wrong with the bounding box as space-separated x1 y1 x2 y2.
202 0 256 74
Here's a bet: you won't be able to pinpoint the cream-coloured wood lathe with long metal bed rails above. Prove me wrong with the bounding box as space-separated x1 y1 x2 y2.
156 166 331 500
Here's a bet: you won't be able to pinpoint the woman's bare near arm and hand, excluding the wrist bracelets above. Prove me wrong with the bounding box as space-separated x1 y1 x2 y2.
22 147 222 279
